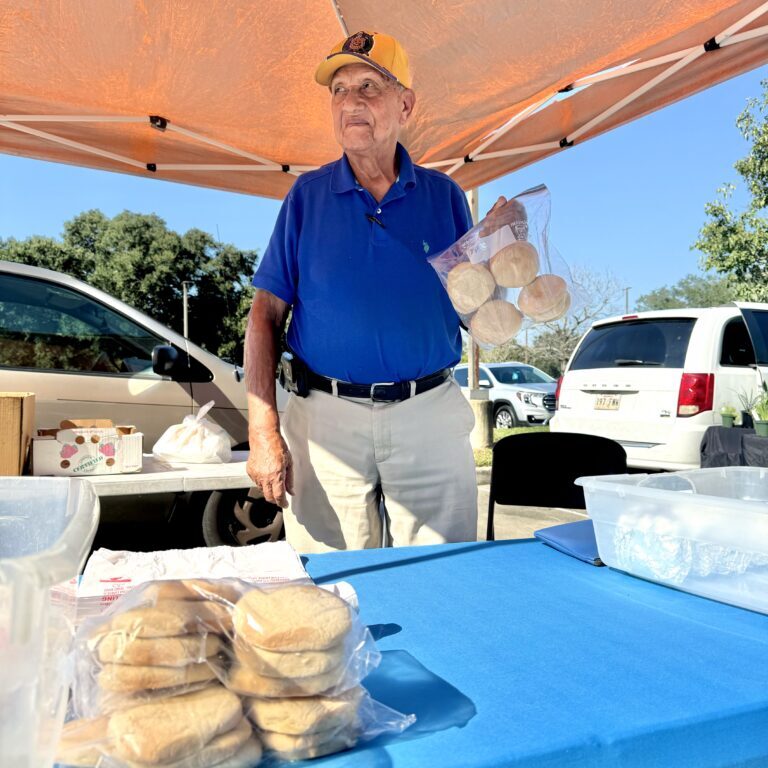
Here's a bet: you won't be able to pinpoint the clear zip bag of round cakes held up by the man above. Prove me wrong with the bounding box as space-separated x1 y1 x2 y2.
429 186 574 349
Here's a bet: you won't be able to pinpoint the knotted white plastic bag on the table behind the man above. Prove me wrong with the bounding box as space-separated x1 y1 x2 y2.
152 400 232 464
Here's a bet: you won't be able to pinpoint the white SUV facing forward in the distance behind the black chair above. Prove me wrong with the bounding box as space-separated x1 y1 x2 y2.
453 362 557 429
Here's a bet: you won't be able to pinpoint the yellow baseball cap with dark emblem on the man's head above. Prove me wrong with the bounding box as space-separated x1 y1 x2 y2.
315 32 411 88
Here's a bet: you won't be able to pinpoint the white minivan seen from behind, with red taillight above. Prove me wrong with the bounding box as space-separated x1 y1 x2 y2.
550 303 768 470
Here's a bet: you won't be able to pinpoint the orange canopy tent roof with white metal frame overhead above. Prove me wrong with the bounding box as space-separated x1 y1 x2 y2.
0 0 768 197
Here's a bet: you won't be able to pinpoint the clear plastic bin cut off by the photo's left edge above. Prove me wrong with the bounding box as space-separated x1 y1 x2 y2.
0 477 99 768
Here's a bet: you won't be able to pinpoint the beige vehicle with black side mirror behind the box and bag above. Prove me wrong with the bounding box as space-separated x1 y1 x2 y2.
0 261 285 444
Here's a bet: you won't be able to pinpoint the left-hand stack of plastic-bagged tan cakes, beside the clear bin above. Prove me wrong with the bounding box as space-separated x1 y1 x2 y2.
62 581 261 768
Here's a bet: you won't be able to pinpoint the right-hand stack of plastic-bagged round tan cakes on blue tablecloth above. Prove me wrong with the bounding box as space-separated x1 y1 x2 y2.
227 585 365 760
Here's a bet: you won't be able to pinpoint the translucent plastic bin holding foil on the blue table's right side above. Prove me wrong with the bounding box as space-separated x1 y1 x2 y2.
576 467 768 613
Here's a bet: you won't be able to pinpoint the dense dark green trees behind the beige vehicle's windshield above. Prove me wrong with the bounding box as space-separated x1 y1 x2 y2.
0 210 258 362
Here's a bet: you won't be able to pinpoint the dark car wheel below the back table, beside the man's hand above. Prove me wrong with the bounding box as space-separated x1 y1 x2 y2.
202 488 285 547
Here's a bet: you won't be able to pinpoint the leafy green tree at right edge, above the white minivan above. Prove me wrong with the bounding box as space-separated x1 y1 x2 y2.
694 80 768 301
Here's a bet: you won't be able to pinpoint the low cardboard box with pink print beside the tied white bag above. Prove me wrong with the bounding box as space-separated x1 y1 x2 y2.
32 419 144 476
